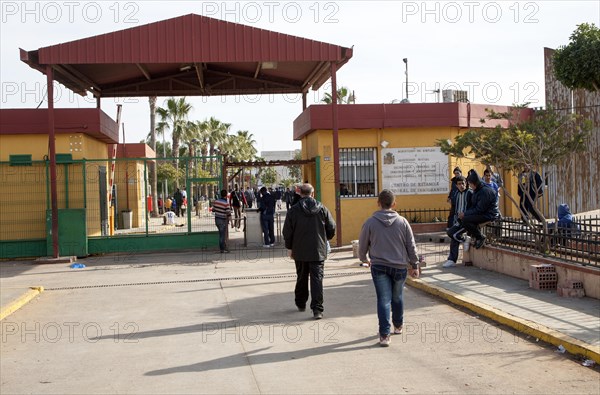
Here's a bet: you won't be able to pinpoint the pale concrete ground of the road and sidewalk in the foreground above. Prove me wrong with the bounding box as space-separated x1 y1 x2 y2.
0 235 600 393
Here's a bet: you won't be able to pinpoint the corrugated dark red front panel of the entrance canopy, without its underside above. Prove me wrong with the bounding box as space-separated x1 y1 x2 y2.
39 14 350 64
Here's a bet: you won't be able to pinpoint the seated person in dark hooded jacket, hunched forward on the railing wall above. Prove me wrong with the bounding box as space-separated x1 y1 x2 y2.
451 170 500 249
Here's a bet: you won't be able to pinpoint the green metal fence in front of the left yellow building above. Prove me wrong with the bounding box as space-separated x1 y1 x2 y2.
0 155 222 258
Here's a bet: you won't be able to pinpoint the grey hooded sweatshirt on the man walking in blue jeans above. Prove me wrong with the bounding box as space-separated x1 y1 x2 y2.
358 210 419 269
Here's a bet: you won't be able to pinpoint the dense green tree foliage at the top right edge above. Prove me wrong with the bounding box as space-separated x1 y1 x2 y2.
553 23 600 92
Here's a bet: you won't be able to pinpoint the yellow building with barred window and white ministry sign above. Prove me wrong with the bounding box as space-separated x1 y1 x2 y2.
294 103 517 244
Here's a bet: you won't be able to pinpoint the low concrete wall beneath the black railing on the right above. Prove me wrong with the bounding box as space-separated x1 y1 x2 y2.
463 246 600 299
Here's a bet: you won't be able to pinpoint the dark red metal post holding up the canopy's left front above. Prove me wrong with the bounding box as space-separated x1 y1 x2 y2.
46 65 59 258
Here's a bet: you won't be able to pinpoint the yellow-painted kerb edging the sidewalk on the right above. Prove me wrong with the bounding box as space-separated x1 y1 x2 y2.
407 278 600 363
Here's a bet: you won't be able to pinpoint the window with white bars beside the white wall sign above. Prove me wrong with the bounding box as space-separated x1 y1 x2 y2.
340 148 377 198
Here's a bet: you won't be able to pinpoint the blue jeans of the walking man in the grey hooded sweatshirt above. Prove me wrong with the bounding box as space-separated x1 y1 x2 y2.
371 265 408 336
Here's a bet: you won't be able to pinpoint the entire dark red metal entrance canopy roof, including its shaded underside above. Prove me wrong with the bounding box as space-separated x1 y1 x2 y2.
21 14 352 97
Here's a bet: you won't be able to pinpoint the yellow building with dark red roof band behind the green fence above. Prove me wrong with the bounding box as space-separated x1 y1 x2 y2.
0 108 154 257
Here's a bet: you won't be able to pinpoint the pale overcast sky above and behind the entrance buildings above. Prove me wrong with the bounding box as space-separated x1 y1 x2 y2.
0 0 600 151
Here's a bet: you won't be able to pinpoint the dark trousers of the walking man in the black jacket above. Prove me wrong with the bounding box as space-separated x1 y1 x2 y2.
294 261 325 312
